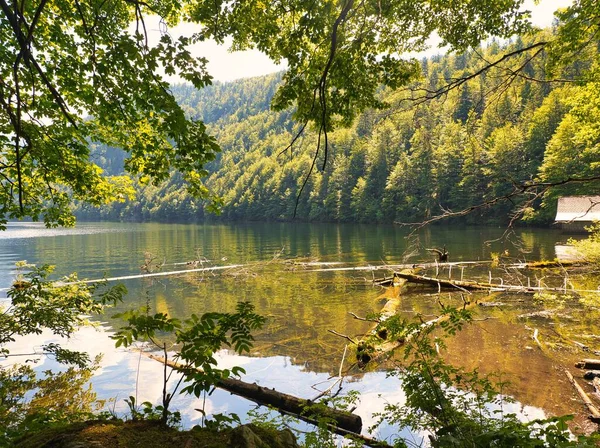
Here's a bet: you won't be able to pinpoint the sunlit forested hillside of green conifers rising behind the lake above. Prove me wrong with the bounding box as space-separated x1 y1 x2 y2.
78 30 600 223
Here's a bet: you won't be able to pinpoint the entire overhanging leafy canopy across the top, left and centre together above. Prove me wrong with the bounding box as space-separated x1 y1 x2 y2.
0 0 548 225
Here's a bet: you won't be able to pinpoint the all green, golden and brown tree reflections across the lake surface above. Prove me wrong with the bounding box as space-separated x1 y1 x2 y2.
23 224 600 412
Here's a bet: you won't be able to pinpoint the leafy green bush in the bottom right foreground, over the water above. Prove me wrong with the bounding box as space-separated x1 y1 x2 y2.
378 307 598 448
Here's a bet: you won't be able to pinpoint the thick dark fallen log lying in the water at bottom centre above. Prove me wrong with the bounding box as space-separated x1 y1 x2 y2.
143 352 362 435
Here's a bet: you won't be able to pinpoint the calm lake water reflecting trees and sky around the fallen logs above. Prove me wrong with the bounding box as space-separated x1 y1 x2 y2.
0 223 598 437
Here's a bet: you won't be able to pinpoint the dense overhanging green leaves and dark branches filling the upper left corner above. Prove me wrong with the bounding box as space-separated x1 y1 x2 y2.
0 0 225 225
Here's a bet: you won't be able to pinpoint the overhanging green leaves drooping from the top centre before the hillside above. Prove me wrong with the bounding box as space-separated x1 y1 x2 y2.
190 0 527 131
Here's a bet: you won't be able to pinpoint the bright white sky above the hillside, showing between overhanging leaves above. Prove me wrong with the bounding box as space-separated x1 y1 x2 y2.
155 0 572 82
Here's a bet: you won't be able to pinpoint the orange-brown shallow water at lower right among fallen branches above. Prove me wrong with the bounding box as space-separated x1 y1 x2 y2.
402 280 600 424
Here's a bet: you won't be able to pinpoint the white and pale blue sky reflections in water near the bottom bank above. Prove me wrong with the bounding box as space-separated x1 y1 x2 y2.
0 327 544 446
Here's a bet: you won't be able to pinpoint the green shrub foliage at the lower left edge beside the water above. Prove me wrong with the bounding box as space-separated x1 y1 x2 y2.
0 262 126 446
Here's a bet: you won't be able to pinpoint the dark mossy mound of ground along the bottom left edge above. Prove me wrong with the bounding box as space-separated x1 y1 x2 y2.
16 420 297 448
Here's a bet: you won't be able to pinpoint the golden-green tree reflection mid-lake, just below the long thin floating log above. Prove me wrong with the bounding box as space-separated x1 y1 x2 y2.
149 266 380 372
